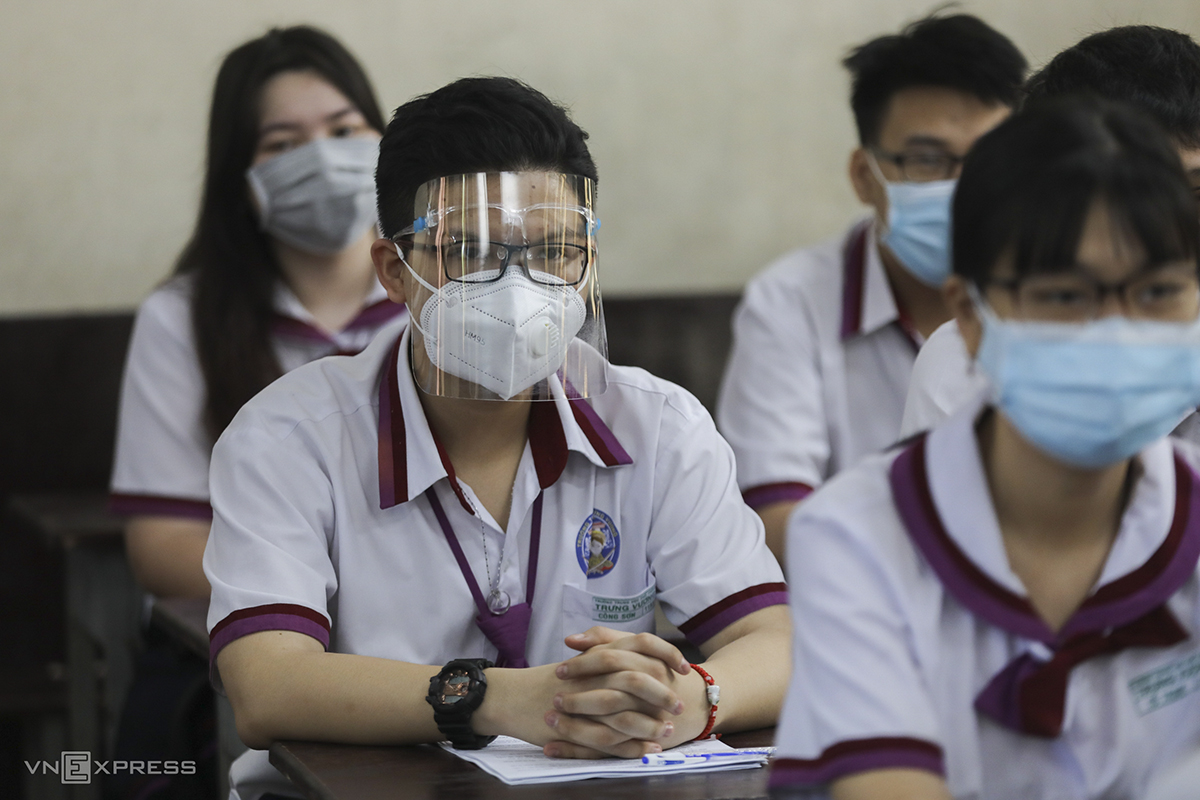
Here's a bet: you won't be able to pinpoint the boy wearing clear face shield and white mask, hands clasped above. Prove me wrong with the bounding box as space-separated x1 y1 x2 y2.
205 78 790 800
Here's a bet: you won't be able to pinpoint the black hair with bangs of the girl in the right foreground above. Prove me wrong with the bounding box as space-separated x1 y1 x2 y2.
953 95 1200 287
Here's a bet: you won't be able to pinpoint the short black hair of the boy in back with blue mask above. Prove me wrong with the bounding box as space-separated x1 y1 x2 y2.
842 14 1027 146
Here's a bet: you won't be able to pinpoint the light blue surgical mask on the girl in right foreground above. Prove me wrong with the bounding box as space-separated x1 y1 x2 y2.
976 295 1200 469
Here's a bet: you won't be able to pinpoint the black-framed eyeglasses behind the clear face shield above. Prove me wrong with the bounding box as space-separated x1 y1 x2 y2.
397 237 595 287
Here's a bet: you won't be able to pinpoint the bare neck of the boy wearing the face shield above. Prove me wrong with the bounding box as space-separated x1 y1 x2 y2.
419 392 532 527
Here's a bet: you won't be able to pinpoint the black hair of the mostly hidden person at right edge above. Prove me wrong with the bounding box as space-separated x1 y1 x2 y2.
1026 25 1200 148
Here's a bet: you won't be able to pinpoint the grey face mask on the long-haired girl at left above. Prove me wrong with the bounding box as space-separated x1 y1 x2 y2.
246 138 379 255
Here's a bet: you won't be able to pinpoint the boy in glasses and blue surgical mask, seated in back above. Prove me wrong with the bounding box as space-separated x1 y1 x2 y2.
716 14 1025 558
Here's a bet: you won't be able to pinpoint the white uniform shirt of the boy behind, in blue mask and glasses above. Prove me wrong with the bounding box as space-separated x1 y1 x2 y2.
716 221 920 507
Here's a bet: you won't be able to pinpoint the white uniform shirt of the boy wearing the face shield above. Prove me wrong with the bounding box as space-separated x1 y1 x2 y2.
204 332 786 798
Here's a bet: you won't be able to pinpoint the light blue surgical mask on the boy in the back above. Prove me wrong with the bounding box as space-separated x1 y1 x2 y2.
866 152 958 287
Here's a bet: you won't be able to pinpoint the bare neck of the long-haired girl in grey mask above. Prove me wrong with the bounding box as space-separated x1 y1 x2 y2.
274 230 376 332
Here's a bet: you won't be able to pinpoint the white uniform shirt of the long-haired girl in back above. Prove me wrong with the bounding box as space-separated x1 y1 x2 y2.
110 276 407 519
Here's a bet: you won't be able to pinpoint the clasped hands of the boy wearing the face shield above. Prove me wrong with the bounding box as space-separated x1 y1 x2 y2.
487 626 709 758
